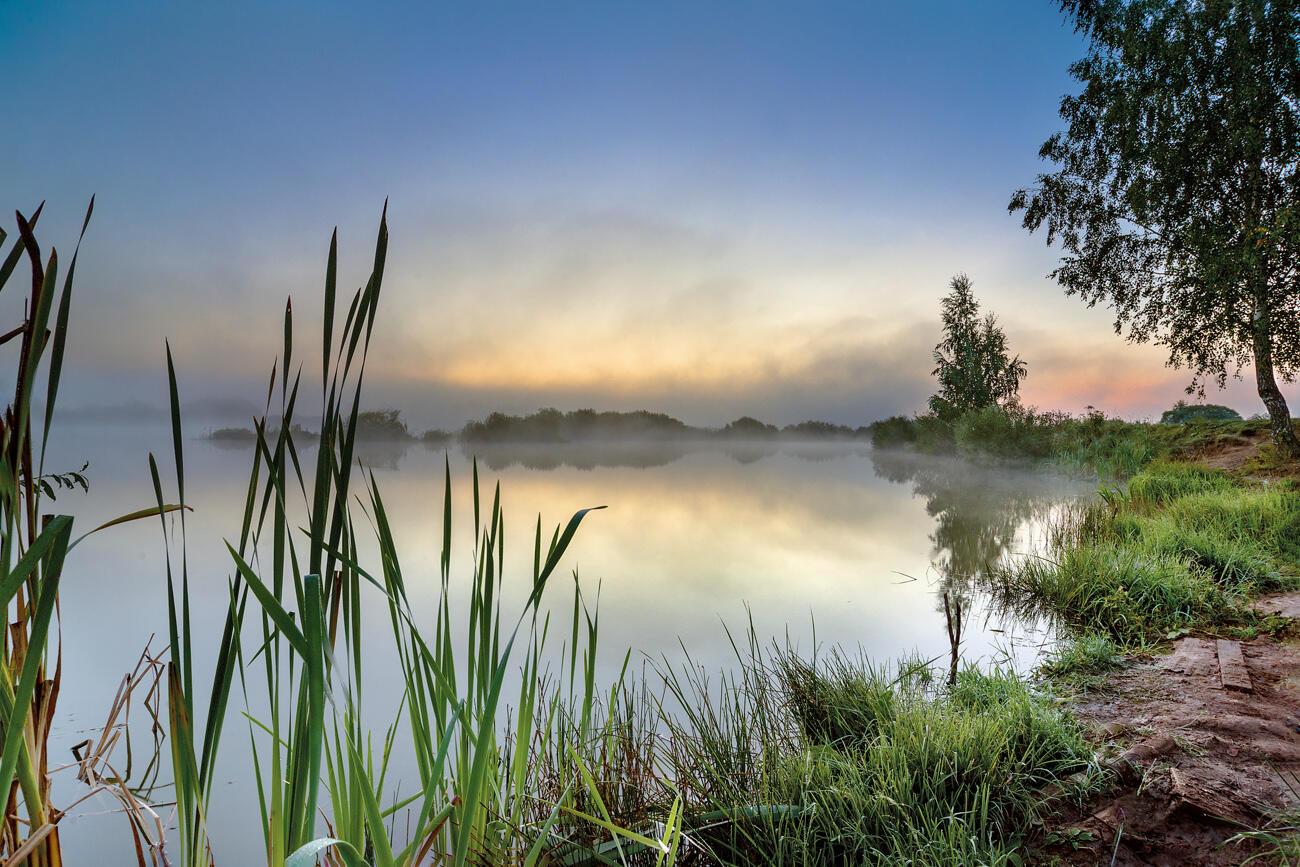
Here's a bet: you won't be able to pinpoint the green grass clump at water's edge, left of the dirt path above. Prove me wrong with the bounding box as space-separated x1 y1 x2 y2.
681 655 1092 866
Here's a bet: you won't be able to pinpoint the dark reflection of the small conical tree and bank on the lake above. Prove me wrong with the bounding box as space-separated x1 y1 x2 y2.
871 450 1066 611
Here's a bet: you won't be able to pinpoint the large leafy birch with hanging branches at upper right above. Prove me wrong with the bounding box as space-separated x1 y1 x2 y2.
1009 0 1300 455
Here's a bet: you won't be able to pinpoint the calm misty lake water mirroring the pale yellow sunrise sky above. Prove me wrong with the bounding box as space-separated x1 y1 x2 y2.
38 426 1092 864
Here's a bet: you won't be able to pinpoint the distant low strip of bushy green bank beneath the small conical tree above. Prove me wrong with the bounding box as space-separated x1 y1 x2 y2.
870 406 1268 480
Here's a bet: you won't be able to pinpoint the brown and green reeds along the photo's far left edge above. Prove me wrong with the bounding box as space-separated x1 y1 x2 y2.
0 199 188 867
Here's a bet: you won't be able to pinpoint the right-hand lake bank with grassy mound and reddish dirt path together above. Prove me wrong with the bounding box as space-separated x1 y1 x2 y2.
989 441 1300 867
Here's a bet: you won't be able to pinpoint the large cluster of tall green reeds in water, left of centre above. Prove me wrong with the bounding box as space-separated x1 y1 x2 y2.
151 210 650 866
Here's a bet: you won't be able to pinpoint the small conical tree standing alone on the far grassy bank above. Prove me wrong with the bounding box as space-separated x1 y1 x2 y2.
930 274 1026 420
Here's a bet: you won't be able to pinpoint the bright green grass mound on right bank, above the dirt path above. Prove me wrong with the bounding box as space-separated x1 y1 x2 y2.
993 461 1300 647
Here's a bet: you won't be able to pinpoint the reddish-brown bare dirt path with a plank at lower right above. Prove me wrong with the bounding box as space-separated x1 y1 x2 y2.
1037 593 1300 867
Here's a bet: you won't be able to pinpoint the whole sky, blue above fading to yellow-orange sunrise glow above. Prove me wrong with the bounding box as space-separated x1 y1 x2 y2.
0 0 1296 428
